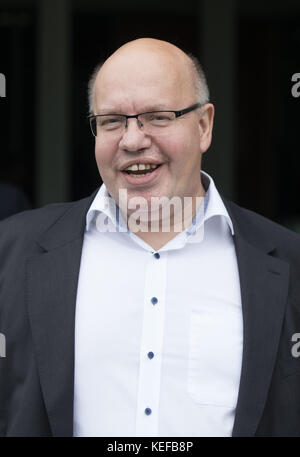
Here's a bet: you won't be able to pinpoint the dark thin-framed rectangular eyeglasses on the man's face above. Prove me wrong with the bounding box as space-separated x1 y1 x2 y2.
88 103 203 136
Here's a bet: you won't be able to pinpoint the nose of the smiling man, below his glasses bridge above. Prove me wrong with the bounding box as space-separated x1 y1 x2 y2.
119 118 151 152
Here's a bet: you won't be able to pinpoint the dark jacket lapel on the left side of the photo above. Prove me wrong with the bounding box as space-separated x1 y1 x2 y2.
27 193 95 436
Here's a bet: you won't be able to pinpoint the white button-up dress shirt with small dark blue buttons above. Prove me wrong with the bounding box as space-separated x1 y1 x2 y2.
74 172 243 437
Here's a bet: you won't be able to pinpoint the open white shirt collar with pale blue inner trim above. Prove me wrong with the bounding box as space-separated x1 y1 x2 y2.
86 170 234 239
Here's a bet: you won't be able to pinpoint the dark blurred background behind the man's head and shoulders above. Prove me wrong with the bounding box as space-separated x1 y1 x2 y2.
0 0 300 228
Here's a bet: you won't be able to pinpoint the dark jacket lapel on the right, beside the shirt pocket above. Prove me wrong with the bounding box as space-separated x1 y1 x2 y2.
224 201 289 437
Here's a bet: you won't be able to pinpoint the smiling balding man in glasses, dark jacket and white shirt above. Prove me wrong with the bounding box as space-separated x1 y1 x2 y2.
0 39 300 437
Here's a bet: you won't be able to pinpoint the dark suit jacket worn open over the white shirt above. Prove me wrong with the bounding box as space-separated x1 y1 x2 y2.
0 188 300 436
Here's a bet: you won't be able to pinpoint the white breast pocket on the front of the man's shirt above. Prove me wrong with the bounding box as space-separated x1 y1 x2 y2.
187 303 243 408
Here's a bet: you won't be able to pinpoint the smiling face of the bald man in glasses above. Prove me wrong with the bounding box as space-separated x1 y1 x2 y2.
94 39 213 219
